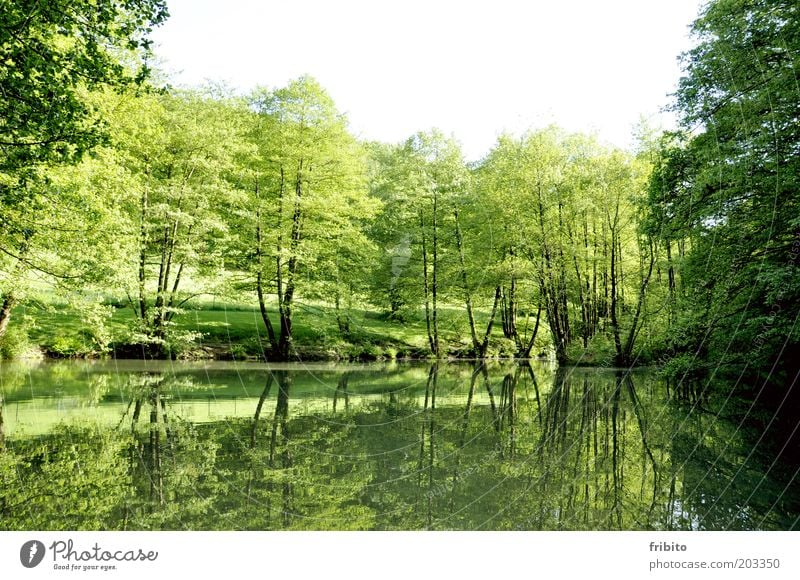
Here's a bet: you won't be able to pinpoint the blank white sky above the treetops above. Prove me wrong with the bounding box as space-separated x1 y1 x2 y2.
152 0 701 160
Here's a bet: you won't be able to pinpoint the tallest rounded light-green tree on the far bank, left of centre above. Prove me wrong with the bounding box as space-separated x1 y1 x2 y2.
241 77 376 360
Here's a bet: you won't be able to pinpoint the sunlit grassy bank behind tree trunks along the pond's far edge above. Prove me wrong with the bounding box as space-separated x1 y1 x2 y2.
4 302 536 360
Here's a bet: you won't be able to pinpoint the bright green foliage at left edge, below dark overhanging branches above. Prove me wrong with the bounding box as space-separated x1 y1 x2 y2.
0 149 133 347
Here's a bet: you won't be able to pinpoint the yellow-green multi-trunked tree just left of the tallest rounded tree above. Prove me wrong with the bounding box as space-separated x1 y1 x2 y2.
109 93 240 353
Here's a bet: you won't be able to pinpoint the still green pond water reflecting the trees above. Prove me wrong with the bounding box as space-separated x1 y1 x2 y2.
0 361 800 530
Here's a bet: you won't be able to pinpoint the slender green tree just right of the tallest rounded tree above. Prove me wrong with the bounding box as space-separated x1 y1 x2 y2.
373 130 477 356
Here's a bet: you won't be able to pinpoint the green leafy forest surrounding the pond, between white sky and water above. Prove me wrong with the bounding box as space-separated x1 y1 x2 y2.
0 0 800 403
